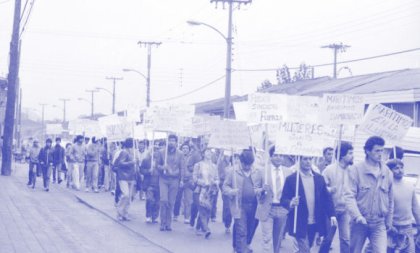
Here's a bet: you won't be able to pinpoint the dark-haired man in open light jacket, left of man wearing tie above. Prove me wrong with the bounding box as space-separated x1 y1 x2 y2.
223 149 258 253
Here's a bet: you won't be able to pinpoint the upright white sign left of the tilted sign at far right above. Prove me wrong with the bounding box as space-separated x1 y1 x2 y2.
321 94 365 125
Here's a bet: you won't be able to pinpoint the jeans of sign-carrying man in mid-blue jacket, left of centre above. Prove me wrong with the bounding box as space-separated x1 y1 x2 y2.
159 178 179 228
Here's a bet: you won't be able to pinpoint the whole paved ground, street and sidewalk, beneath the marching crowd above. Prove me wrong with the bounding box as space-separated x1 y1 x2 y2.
0 165 338 253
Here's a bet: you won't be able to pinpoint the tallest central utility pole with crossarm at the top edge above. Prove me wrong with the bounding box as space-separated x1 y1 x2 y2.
210 0 252 119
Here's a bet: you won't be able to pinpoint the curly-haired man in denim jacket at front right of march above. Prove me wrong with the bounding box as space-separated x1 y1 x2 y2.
344 136 394 253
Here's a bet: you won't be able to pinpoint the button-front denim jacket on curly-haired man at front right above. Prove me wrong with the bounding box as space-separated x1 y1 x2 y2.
344 161 394 226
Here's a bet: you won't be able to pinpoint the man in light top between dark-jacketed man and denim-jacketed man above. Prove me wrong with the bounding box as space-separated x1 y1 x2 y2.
322 142 353 253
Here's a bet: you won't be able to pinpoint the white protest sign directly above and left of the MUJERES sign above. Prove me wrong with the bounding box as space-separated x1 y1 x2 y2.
248 93 287 124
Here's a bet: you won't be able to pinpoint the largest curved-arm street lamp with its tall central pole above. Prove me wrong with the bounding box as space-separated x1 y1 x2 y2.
187 18 232 118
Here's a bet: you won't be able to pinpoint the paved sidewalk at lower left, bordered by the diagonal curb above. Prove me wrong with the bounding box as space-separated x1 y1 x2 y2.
0 166 170 253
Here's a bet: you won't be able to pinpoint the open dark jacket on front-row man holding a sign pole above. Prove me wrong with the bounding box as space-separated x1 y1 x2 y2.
280 172 335 238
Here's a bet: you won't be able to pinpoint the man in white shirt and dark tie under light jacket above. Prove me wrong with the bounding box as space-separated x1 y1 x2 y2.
254 146 292 253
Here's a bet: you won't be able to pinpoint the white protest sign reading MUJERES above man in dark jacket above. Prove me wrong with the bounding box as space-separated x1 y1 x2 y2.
276 121 325 156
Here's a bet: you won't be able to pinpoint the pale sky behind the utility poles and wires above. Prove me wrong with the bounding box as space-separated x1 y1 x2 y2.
0 0 420 120
